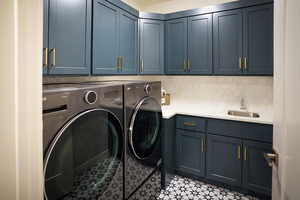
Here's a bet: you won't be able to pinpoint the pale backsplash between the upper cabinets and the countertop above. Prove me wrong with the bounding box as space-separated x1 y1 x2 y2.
44 76 273 114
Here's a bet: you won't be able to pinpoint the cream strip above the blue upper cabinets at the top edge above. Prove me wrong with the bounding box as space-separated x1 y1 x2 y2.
123 0 235 13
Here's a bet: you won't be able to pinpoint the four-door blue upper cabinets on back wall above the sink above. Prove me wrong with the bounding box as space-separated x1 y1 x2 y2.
166 4 273 75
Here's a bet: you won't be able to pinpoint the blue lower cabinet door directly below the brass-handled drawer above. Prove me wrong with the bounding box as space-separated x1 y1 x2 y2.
176 129 205 177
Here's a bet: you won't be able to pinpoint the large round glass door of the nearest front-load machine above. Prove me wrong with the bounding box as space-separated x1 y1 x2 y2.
44 109 123 200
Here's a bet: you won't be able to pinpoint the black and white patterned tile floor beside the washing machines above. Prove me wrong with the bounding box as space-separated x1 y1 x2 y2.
130 174 258 200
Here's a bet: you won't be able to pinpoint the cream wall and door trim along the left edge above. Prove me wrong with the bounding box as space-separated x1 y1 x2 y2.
0 0 43 200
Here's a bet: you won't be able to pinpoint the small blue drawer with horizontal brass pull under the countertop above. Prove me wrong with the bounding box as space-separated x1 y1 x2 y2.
176 116 206 132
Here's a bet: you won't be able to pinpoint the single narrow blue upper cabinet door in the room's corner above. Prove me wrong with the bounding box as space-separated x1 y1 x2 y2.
140 19 164 74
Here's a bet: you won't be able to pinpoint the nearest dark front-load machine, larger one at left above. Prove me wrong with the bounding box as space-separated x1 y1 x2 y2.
43 84 124 200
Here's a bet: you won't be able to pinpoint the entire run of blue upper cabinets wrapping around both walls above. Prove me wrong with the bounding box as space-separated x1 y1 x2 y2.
43 0 273 75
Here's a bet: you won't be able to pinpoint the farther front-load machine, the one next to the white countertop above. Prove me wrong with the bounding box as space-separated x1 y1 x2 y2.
124 82 162 199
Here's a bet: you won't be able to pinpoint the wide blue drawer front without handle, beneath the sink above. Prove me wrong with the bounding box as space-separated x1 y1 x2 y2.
207 119 273 143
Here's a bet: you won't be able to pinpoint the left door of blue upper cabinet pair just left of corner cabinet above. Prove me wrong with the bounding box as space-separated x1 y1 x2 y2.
92 0 119 74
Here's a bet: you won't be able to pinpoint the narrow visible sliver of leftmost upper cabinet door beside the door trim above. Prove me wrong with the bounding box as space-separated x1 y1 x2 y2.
43 0 49 75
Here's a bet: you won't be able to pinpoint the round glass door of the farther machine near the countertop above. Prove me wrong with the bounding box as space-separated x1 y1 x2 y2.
129 97 162 160
